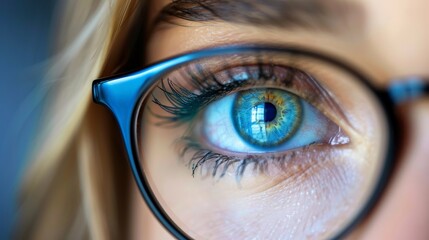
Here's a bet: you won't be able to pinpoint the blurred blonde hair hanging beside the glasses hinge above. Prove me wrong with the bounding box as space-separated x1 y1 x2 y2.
15 0 147 239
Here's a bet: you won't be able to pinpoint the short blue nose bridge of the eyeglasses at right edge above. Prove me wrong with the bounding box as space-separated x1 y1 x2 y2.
387 76 429 105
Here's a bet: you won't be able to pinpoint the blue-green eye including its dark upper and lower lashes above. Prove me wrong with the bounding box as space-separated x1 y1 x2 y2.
153 64 350 178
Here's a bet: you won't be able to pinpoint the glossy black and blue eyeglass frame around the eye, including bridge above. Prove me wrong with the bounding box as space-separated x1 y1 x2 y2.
92 46 429 239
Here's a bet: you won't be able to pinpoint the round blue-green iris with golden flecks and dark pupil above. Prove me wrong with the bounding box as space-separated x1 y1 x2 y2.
232 88 302 147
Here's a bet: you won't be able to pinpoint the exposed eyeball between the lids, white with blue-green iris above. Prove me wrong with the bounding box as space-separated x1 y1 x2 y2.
200 88 348 153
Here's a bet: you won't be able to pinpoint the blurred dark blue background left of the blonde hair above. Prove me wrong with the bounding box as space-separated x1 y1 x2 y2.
0 0 59 239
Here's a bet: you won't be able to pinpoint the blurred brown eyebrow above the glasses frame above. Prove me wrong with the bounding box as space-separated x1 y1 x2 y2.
155 0 365 32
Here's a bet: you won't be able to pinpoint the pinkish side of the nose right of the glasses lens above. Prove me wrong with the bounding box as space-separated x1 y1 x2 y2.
361 99 429 240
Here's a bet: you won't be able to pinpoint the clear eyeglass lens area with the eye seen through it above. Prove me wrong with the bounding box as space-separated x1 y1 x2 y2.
135 51 387 239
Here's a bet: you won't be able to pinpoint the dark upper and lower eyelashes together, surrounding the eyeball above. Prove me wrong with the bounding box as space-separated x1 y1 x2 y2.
151 61 341 179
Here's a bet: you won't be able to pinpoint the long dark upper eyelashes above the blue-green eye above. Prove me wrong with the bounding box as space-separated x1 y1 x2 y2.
152 63 300 125
